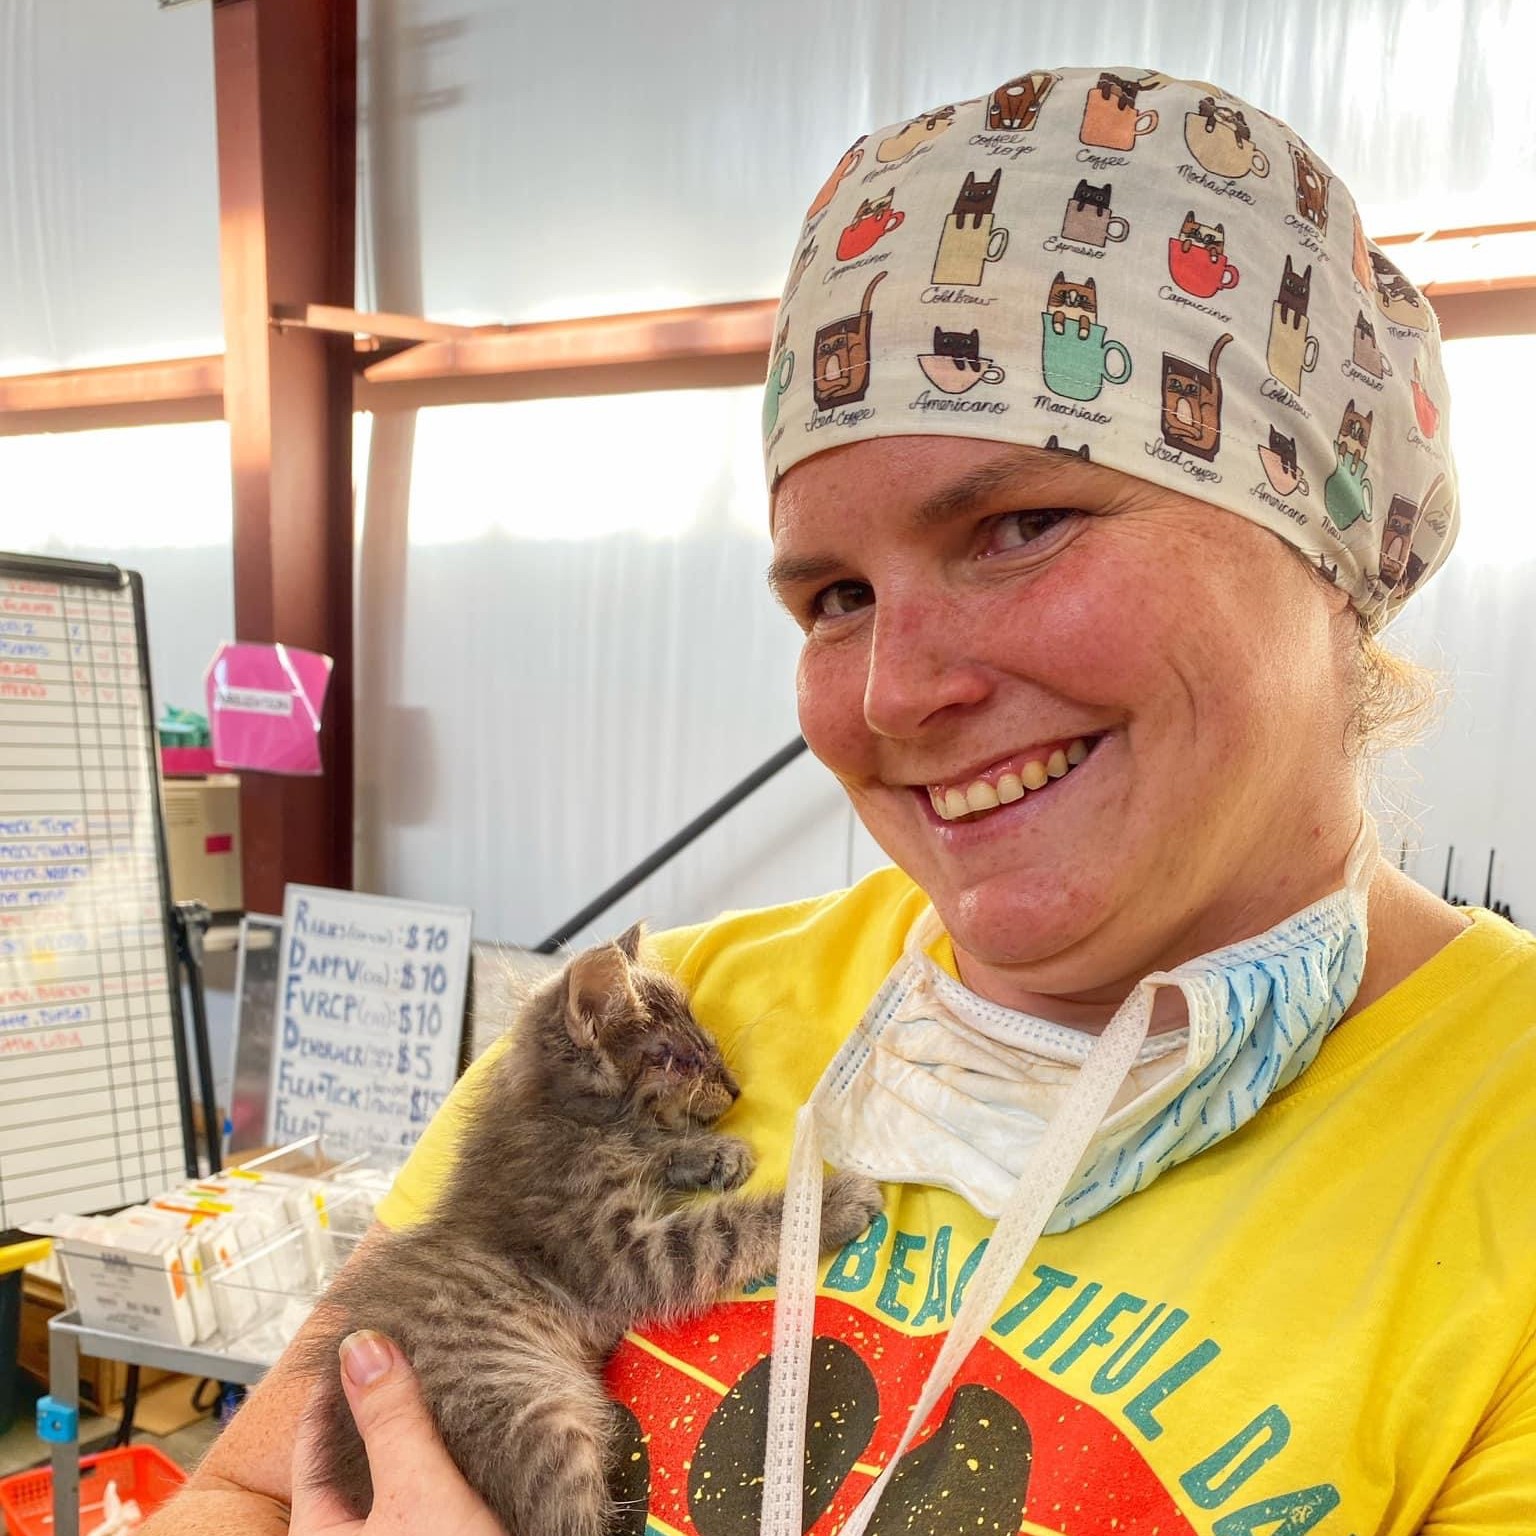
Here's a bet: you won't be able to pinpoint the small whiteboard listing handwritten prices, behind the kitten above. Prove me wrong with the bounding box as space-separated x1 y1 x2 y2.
267 885 470 1155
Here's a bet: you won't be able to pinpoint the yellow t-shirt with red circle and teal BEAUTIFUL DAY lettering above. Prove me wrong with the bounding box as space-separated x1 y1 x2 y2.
379 869 1536 1536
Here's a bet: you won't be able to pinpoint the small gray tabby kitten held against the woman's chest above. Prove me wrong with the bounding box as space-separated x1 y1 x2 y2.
306 928 880 1536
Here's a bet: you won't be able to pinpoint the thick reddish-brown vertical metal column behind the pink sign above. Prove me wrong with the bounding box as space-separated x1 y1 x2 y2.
214 0 356 912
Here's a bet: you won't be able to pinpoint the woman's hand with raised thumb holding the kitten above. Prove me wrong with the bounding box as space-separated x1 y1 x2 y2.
289 1332 507 1536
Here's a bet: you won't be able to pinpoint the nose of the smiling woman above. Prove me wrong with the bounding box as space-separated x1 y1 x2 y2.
865 599 991 739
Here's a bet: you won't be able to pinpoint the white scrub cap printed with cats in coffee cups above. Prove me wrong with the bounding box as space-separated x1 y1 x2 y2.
763 69 1458 628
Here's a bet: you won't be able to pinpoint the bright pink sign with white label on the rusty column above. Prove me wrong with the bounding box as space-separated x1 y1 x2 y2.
203 642 332 774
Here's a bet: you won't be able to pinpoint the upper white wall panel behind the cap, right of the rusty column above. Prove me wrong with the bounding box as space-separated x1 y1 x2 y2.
353 0 1536 321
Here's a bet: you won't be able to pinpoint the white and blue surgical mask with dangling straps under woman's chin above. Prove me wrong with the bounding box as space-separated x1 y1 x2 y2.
762 817 1378 1536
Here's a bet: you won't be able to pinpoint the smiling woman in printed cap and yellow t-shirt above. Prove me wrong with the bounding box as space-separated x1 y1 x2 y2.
146 54 1536 1536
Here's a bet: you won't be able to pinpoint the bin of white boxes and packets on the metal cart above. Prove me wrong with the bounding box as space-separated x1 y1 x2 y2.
31 1137 398 1361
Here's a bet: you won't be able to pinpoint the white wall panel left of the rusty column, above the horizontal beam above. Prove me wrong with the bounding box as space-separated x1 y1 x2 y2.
0 0 224 373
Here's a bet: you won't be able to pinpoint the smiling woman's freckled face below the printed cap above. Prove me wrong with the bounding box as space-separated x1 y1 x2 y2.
773 436 1359 1021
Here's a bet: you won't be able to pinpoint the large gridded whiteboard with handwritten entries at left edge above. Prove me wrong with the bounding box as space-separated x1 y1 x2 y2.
0 556 186 1229
